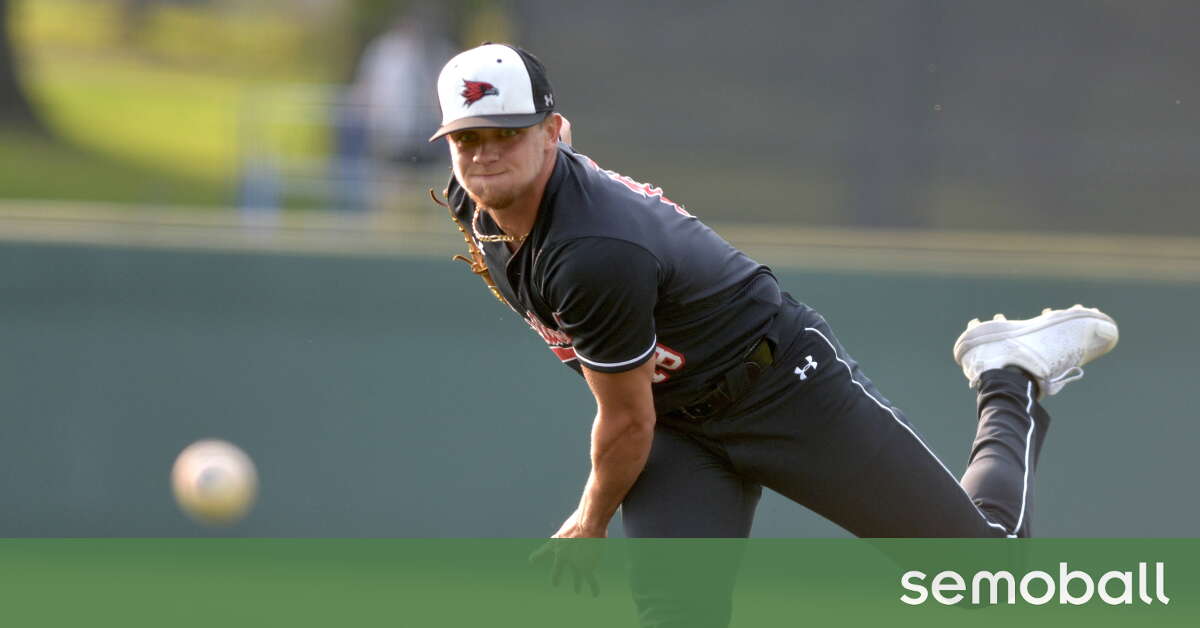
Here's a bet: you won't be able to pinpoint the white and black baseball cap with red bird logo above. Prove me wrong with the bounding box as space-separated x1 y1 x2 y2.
430 43 554 142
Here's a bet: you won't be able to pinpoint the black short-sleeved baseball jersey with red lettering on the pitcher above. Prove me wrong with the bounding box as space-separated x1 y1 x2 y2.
448 143 781 413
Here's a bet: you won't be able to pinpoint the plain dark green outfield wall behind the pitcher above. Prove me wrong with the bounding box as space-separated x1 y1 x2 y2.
0 244 1200 537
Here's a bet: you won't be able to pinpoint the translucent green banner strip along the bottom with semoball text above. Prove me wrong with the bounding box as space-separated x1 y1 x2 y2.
0 539 1200 628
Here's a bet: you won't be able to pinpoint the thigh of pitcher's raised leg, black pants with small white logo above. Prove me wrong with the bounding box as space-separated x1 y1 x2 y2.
714 306 1007 537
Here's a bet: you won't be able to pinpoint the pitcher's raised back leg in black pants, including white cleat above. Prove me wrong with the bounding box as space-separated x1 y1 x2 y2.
731 302 1116 537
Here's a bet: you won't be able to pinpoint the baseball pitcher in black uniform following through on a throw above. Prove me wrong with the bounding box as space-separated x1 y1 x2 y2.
431 44 1117 624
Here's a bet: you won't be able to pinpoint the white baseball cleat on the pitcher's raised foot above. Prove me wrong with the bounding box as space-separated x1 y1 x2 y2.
954 305 1117 399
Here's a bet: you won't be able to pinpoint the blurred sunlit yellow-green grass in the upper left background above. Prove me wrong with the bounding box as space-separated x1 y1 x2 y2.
9 0 337 205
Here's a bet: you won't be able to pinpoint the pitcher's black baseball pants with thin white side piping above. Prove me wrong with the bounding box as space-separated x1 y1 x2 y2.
622 298 1050 626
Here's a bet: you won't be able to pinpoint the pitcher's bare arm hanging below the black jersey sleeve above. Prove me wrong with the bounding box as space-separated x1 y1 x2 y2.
554 360 655 538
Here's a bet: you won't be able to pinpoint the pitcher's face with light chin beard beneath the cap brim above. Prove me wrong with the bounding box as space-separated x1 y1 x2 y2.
446 125 554 209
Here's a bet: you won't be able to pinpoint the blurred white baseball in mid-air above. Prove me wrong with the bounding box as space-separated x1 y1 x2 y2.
170 439 258 525
